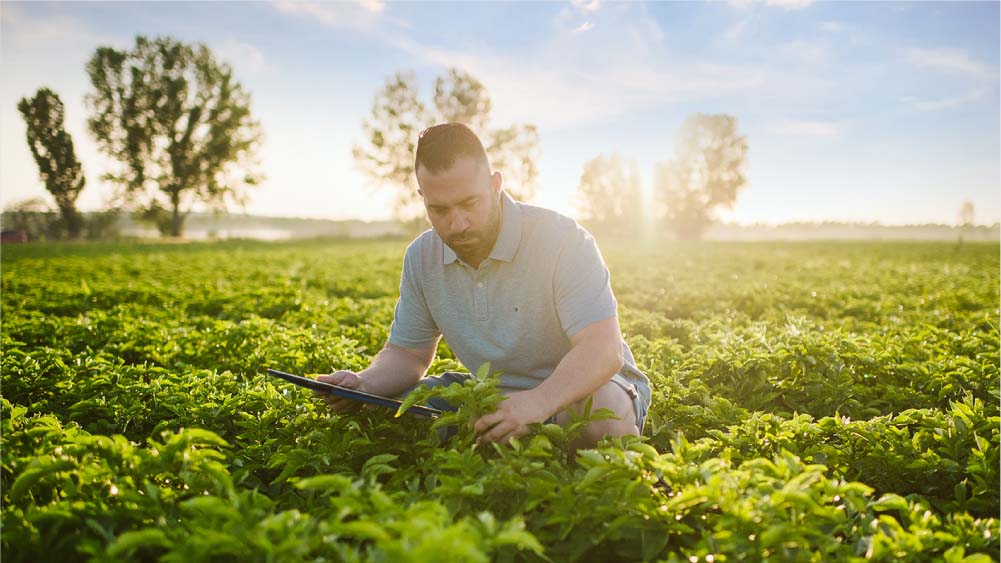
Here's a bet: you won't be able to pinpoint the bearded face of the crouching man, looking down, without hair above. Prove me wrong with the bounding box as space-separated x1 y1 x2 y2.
417 156 501 266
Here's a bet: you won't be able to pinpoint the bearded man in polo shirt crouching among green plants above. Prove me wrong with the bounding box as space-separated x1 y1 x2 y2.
317 123 651 445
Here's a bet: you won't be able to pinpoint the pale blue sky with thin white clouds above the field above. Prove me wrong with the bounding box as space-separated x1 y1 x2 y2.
0 0 1001 224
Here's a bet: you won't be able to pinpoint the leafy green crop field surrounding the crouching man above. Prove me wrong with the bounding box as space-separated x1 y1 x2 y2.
0 237 1001 563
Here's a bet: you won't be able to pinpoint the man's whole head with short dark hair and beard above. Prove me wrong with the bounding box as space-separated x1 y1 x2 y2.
413 123 503 266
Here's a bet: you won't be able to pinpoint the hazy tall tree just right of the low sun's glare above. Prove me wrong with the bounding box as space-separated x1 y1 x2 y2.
654 113 748 238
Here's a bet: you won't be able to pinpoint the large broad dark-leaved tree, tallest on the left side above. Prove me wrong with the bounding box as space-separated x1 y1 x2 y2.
86 35 261 236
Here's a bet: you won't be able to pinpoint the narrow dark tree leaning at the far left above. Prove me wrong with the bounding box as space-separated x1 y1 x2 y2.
17 88 87 238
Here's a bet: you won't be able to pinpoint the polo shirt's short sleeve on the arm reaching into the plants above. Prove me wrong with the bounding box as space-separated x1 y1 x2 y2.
554 225 617 338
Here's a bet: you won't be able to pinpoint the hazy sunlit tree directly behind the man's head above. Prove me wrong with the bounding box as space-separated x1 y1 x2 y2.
352 68 539 220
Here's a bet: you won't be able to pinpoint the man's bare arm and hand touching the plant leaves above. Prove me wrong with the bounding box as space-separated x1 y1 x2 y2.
474 317 625 442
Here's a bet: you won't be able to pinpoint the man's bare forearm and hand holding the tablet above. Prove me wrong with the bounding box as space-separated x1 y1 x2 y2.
316 343 436 412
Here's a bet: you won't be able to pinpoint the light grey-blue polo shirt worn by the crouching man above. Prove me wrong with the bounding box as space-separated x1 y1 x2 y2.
389 193 650 394
